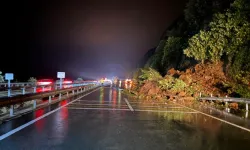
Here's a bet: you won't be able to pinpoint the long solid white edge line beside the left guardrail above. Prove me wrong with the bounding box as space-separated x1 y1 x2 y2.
0 88 99 141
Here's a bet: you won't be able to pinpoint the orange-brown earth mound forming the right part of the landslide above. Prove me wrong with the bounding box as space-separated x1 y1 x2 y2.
168 62 227 96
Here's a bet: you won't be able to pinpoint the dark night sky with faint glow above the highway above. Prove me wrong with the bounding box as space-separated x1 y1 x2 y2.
0 0 186 79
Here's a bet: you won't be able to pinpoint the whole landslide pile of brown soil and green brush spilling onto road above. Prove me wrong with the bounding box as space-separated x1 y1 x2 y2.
133 62 234 101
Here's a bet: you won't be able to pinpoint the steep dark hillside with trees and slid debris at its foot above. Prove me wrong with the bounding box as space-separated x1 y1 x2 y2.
133 0 250 100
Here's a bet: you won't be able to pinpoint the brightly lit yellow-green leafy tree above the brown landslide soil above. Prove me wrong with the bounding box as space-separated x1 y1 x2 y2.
184 0 250 63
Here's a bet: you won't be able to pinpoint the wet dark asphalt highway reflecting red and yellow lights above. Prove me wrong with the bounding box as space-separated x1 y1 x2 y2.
0 87 250 150
